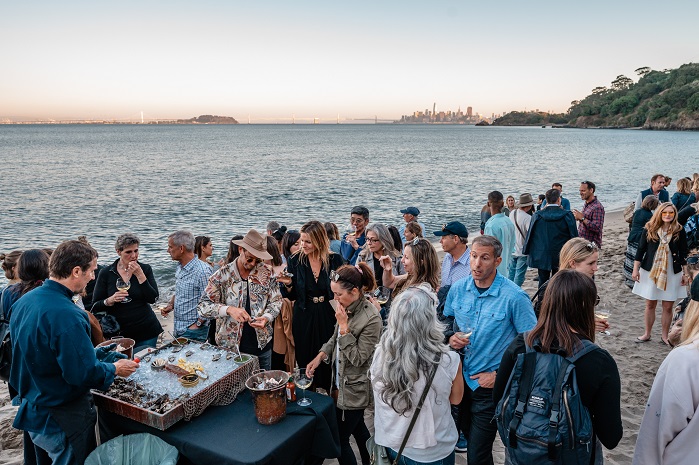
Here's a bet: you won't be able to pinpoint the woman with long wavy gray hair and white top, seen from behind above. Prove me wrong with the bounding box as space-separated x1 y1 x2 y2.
370 284 464 465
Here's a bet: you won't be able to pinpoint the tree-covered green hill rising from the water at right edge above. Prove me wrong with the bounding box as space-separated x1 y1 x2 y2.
568 63 699 130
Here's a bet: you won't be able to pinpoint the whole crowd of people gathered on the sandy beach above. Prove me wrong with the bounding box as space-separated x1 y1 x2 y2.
0 175 699 465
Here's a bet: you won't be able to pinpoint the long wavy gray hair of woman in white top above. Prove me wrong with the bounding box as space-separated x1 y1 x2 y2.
373 284 449 415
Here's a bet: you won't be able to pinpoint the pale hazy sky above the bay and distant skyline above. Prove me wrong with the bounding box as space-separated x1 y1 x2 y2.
0 0 699 121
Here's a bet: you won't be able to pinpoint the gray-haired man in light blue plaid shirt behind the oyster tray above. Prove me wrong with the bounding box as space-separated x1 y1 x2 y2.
160 230 212 342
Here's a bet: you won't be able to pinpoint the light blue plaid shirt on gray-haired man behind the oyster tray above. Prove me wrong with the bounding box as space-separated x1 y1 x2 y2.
174 257 212 336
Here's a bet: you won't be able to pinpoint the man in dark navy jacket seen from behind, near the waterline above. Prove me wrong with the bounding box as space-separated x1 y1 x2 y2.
522 189 578 287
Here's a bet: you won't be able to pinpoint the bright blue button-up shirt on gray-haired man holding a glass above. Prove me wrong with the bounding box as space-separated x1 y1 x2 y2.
444 272 536 391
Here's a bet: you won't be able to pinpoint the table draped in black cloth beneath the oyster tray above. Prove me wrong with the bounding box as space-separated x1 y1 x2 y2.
99 390 340 465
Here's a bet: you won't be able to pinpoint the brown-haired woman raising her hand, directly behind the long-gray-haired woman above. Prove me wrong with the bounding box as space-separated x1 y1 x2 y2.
381 237 441 296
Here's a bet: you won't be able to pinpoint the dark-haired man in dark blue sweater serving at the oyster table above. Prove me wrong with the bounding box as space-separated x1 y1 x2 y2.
10 241 138 464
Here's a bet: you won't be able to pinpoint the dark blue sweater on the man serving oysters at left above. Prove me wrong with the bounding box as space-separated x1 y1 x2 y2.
10 280 116 434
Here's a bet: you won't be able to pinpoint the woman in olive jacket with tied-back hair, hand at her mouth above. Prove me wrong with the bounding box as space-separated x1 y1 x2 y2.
306 263 382 465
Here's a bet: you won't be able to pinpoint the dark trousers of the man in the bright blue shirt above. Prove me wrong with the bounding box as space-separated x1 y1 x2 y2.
459 384 498 465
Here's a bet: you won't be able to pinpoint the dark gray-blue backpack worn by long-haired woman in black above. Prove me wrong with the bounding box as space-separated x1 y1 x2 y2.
495 333 599 465
